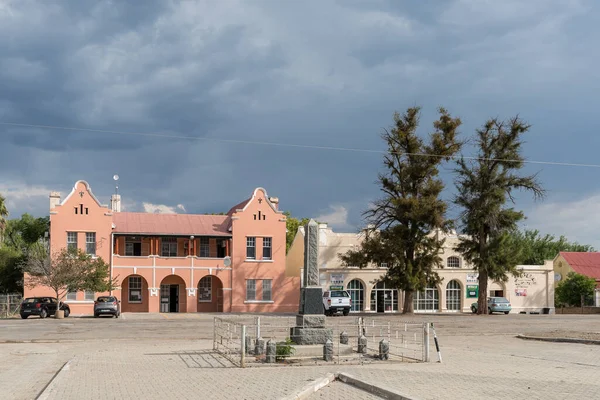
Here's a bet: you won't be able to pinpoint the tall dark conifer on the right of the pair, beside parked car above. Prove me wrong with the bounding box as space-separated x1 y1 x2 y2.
454 117 544 314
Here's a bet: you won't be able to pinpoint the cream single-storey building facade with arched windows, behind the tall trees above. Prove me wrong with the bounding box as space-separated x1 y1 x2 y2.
287 224 554 313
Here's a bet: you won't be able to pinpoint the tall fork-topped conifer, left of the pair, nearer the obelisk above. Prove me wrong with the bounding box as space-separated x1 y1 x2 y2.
340 107 461 314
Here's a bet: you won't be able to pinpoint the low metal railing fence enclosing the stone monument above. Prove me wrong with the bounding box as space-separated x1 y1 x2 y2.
213 316 430 368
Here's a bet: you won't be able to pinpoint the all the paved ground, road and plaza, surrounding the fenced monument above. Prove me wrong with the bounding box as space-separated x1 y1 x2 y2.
0 314 600 399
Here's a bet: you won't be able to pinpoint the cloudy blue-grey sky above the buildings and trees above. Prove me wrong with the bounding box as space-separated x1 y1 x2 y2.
0 0 600 248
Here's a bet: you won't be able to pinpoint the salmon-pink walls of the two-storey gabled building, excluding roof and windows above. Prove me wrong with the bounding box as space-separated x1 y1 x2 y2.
25 181 300 314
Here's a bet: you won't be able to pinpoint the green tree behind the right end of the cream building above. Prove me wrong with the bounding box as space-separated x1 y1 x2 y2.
510 230 595 265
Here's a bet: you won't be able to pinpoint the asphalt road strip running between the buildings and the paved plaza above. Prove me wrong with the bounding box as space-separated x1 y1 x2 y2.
0 314 600 343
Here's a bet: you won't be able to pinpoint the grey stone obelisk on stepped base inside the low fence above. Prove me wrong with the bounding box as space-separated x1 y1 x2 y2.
290 219 333 345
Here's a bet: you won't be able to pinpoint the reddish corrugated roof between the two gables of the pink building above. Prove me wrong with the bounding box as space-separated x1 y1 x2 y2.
113 212 231 236
